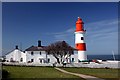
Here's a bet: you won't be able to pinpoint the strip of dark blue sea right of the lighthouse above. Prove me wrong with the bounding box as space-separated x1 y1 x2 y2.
87 55 120 61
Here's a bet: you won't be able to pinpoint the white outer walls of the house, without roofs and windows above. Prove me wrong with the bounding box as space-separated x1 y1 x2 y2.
6 49 78 63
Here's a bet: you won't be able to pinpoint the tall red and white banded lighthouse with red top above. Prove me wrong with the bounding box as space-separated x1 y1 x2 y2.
75 17 87 61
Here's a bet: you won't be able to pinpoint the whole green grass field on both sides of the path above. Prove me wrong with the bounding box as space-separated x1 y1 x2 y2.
3 66 120 80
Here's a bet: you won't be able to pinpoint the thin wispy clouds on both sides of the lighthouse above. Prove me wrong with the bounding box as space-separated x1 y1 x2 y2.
44 19 118 49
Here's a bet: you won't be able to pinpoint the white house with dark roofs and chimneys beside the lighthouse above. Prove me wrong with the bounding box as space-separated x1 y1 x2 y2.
6 41 78 64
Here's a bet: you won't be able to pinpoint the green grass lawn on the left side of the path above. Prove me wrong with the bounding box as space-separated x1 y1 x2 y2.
3 66 83 80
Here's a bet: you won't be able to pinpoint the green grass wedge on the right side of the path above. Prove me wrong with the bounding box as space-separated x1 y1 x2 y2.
61 68 120 80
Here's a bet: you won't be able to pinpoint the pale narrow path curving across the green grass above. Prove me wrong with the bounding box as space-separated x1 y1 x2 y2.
55 67 104 80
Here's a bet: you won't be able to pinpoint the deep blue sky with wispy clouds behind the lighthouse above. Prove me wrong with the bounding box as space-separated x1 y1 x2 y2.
2 2 118 55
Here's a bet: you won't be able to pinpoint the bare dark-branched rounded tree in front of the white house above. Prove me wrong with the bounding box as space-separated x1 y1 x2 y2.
46 41 74 63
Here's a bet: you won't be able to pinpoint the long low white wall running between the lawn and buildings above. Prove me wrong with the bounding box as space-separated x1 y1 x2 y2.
3 62 120 68
